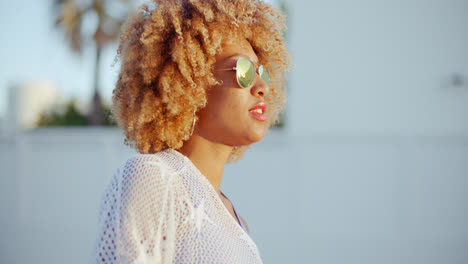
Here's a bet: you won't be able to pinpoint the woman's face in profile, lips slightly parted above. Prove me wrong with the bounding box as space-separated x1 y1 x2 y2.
195 39 270 146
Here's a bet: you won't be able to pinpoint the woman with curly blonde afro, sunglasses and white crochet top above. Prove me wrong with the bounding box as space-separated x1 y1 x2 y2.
91 0 288 263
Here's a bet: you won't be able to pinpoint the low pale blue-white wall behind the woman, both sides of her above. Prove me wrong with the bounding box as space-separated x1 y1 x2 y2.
0 128 468 264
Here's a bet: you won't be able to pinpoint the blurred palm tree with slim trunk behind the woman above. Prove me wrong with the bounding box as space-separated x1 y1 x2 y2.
53 0 131 125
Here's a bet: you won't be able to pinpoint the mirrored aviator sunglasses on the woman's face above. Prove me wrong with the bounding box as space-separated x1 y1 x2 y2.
216 58 270 88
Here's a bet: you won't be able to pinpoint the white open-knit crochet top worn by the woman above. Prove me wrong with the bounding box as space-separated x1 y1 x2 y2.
90 149 262 264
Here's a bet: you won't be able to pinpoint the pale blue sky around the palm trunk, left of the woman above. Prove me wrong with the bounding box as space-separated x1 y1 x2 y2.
0 0 272 119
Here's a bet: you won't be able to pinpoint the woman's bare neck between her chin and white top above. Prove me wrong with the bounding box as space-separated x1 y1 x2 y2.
178 133 232 194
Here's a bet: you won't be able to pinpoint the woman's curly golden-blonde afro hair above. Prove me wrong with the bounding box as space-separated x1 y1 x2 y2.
112 0 289 162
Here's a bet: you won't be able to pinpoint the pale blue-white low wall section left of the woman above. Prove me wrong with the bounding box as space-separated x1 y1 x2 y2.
0 128 131 263
